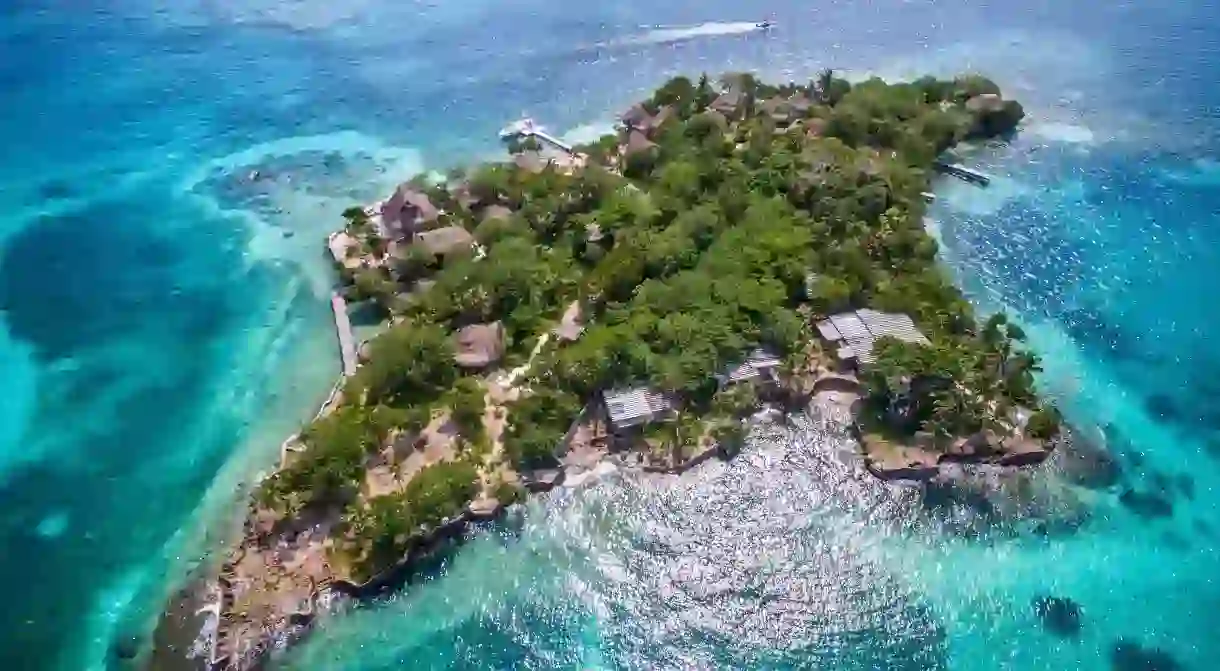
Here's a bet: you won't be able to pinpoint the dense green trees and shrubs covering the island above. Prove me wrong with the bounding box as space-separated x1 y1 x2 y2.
254 72 1057 578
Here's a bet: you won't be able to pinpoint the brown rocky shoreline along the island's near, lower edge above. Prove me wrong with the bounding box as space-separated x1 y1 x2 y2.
149 373 1055 671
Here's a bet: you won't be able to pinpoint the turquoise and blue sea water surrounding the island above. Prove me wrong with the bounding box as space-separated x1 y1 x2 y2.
0 0 1220 671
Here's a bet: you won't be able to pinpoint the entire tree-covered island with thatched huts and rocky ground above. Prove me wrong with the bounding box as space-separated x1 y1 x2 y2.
176 71 1060 669
